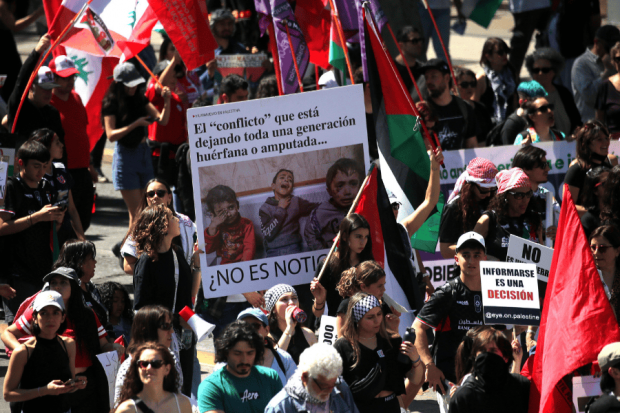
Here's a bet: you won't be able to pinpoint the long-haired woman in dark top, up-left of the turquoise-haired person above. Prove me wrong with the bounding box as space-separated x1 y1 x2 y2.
474 37 517 123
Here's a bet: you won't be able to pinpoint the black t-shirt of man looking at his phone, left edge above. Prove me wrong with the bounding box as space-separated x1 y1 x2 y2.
0 177 55 287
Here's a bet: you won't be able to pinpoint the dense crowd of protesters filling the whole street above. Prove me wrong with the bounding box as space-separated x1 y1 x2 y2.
0 0 620 413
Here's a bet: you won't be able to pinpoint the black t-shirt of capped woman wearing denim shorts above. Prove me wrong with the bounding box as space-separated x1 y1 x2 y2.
101 92 149 148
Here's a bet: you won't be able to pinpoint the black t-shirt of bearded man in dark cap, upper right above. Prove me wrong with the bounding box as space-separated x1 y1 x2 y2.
430 96 477 151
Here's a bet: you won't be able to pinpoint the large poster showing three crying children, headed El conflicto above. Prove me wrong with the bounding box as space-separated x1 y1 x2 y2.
187 85 370 298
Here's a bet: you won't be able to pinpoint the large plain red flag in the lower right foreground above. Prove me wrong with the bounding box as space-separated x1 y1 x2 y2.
529 184 620 413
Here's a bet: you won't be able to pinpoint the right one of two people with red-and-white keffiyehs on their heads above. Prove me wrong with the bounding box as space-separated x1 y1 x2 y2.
474 168 543 261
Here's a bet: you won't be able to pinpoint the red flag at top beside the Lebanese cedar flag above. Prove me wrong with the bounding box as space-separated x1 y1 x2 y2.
149 0 218 70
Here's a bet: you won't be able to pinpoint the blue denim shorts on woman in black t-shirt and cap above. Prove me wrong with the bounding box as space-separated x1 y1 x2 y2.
112 142 155 191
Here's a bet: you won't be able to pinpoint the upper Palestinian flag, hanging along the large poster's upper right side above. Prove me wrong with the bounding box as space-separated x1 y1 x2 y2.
364 6 443 252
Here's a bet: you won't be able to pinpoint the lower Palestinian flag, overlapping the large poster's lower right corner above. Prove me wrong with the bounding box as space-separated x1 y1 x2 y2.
355 168 424 335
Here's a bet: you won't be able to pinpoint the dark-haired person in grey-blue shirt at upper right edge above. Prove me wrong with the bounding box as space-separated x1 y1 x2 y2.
571 25 620 123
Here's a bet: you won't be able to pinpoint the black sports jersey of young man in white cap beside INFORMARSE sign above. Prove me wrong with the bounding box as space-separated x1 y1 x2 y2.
417 278 483 383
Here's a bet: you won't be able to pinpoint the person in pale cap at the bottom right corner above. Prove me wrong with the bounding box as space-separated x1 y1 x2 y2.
589 343 620 413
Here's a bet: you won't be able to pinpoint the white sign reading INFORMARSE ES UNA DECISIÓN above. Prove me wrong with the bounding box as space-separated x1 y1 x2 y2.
480 261 540 326
